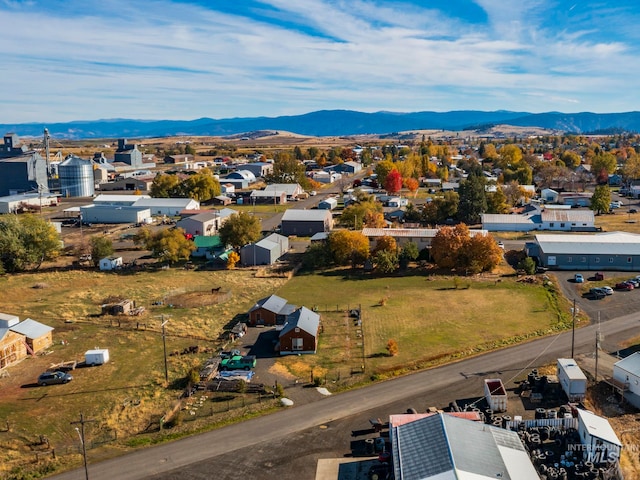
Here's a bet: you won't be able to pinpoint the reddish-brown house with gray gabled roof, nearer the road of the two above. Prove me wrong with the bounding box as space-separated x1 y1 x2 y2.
278 307 320 355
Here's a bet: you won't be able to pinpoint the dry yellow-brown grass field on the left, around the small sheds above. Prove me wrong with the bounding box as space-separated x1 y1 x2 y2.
0 269 284 478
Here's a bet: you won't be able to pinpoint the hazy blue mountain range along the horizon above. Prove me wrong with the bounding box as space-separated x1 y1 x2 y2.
0 110 640 140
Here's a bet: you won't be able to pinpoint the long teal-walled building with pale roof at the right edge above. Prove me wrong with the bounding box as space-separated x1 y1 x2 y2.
528 232 640 271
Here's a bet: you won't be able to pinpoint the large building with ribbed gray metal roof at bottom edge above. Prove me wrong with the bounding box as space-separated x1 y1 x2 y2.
389 413 540 480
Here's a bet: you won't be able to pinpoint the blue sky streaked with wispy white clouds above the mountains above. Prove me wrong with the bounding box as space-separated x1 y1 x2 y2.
0 0 640 123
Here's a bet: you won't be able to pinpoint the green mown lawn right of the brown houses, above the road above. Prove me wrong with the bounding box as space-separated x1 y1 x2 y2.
277 270 565 377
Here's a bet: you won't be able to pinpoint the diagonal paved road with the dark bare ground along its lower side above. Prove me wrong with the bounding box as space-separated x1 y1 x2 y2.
52 313 640 480
